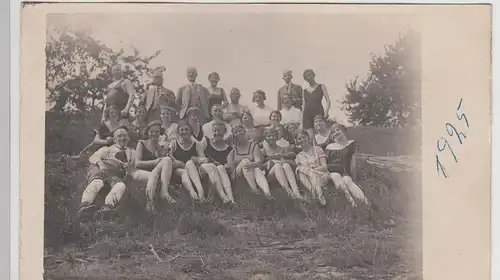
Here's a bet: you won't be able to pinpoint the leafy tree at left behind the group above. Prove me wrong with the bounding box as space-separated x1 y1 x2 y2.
45 26 161 114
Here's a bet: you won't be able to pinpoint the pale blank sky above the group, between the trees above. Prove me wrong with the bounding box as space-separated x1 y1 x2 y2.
48 9 414 123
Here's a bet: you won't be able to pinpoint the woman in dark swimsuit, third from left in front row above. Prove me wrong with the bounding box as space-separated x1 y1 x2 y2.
169 120 220 201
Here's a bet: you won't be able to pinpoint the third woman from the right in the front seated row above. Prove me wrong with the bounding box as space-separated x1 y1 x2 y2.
262 128 303 199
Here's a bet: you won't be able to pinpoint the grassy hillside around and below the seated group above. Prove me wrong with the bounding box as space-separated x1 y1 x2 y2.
44 112 421 280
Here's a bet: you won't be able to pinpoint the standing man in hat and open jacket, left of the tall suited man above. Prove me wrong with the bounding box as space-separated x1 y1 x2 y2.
141 69 176 123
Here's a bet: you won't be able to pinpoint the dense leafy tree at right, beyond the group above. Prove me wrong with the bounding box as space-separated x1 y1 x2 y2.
341 30 421 127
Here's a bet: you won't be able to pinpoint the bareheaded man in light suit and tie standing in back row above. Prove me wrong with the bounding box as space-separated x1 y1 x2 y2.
176 67 210 124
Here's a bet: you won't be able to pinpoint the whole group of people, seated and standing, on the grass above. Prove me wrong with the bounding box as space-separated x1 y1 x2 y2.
75 65 370 221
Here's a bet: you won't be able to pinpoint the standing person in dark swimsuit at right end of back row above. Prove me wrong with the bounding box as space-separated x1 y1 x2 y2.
302 69 330 138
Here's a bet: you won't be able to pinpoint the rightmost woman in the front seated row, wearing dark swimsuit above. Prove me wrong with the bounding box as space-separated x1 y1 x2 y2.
325 124 370 205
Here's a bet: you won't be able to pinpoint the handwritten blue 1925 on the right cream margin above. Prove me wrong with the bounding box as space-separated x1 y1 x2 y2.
436 99 469 178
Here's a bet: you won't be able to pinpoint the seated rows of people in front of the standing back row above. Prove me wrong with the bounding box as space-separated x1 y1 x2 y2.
80 101 369 220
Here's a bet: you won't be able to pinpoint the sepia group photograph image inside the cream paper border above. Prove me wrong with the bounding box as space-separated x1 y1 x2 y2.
43 4 423 280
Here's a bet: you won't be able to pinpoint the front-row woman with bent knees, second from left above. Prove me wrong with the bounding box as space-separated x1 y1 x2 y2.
136 121 175 212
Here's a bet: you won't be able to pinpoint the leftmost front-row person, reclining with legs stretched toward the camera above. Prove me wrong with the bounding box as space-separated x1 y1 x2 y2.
78 126 150 219
